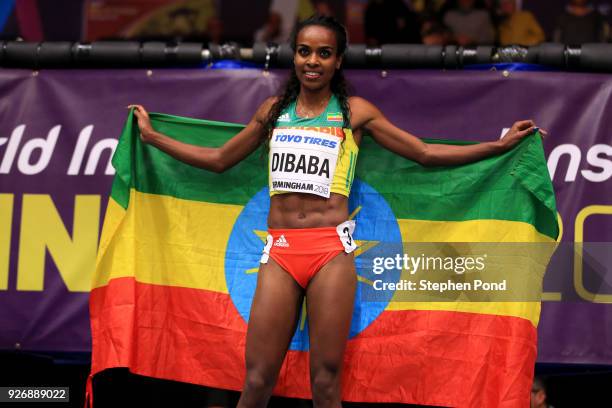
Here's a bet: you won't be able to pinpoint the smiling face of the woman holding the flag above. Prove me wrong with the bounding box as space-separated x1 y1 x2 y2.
293 26 342 90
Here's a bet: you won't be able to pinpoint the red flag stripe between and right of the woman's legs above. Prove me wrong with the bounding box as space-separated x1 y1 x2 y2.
275 310 537 408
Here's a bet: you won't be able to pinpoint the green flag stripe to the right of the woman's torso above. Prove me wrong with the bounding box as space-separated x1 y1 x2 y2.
357 136 558 238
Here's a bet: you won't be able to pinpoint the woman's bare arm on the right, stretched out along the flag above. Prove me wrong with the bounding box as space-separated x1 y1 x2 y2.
350 97 545 166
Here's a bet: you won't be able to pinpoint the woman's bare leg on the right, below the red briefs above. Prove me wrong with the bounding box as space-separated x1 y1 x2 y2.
306 252 357 408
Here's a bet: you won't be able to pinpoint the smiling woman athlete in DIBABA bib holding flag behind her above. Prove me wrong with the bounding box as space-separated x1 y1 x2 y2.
133 16 537 407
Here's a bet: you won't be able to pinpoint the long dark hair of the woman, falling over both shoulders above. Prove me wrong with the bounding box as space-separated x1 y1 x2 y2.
262 14 351 139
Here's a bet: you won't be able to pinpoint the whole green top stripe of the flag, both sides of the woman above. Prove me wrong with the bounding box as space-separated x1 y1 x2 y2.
112 113 558 238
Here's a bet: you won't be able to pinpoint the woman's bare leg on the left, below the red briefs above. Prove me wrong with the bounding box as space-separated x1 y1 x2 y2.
238 258 304 408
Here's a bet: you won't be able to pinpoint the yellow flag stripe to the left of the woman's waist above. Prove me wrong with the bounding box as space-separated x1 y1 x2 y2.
93 189 243 293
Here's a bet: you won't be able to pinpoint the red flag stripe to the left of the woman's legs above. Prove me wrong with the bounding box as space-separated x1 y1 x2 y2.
90 278 246 390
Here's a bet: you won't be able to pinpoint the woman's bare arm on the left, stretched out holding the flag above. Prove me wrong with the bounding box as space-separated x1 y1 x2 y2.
129 97 275 173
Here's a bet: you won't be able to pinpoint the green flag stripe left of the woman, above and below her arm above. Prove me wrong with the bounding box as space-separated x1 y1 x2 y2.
113 113 267 205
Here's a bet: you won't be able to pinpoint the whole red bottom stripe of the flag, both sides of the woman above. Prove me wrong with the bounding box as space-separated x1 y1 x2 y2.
90 278 537 407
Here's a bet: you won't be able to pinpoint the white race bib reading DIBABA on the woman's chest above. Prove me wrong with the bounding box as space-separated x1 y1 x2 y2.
270 129 342 198
